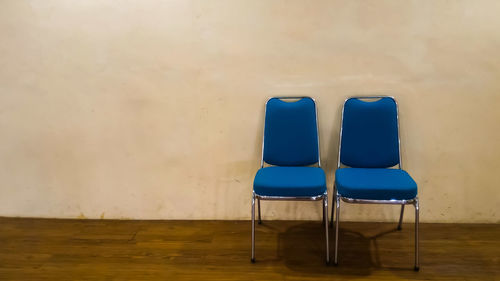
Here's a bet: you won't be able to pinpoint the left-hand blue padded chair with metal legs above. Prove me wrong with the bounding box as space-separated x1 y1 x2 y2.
252 97 330 263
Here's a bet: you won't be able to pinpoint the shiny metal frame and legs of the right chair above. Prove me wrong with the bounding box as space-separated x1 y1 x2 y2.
330 96 420 271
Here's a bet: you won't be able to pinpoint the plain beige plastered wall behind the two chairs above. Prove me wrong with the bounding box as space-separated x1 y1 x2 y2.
0 0 500 222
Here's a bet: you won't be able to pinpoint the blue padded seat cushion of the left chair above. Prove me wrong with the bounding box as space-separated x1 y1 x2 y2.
253 167 326 197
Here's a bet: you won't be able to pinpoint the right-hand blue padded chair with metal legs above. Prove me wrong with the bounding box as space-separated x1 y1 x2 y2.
331 96 419 271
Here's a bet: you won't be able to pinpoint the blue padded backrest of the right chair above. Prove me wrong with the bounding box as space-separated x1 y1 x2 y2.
339 97 401 168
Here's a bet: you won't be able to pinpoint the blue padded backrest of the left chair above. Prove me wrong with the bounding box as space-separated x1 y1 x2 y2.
262 97 319 166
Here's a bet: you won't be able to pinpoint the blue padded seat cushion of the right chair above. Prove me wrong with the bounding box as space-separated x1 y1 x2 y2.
335 168 417 200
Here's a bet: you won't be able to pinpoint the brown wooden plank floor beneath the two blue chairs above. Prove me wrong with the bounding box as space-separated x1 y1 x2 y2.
0 218 500 280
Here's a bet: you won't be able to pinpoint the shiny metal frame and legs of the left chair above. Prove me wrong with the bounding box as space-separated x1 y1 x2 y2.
251 96 330 264
